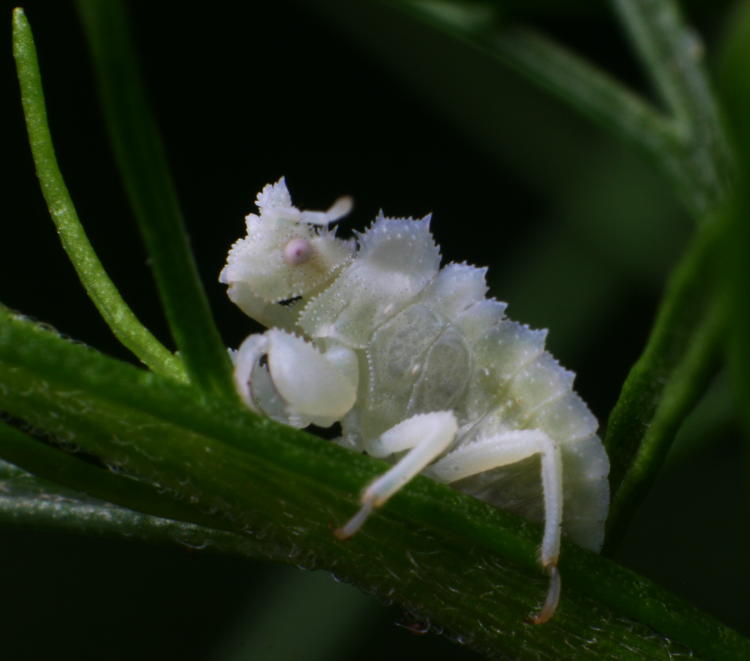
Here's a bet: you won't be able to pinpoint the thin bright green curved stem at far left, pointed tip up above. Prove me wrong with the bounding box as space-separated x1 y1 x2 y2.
13 9 186 380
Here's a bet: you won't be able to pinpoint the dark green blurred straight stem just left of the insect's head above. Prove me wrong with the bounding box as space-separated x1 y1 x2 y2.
77 0 236 400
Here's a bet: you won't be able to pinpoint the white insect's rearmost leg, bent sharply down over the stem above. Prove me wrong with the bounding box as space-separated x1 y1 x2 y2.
429 429 563 624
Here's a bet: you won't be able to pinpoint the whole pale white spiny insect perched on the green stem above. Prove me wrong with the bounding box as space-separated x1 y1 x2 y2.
220 178 609 622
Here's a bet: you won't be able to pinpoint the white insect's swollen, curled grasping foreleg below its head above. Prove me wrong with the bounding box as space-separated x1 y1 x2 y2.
234 328 357 427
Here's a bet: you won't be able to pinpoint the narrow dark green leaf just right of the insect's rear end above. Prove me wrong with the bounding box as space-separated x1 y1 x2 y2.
604 222 725 548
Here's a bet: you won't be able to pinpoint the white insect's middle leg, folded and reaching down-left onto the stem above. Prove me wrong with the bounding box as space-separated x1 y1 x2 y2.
336 411 458 539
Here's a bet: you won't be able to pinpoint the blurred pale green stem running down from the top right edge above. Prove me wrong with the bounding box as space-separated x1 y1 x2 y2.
613 0 734 220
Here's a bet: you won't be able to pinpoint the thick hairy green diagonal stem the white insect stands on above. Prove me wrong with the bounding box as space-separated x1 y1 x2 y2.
0 312 750 660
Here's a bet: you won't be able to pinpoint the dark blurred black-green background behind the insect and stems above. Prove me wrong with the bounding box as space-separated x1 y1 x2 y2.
0 0 750 661
